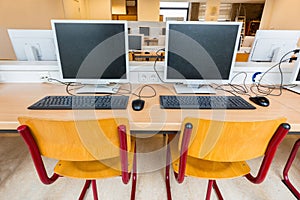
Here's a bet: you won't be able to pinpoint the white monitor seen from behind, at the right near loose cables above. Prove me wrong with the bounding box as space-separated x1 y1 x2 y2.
248 30 300 62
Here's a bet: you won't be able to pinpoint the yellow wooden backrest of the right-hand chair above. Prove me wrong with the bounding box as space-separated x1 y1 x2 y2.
179 118 286 162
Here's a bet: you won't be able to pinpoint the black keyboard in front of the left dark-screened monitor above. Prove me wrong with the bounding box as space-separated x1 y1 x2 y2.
28 96 128 110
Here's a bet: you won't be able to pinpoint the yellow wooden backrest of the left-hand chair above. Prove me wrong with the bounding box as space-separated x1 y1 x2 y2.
18 117 131 161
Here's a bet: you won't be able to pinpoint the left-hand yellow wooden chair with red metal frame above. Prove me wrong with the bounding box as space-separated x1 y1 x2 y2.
18 117 137 199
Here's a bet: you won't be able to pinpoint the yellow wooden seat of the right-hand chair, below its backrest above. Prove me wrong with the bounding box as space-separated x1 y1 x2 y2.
173 156 250 180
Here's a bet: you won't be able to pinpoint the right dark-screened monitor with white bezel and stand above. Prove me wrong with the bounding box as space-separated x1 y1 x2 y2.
164 21 241 93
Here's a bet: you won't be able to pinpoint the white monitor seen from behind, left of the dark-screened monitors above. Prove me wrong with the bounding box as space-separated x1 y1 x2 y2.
7 29 56 61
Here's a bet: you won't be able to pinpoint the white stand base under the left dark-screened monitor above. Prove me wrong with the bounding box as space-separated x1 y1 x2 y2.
76 84 120 94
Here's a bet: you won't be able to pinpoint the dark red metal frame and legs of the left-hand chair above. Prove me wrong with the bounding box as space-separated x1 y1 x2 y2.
17 125 137 200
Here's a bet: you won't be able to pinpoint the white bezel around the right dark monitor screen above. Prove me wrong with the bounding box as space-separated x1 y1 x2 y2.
163 21 242 85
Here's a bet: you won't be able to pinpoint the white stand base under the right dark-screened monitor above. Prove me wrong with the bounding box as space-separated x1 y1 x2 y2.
174 84 216 94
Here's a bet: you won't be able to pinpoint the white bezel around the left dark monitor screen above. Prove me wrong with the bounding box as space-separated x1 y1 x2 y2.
51 20 129 85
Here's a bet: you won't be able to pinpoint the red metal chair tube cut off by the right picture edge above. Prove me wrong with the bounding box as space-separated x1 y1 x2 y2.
282 139 300 199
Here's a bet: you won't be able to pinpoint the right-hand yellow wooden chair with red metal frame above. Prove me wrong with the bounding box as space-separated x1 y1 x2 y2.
165 118 290 200
